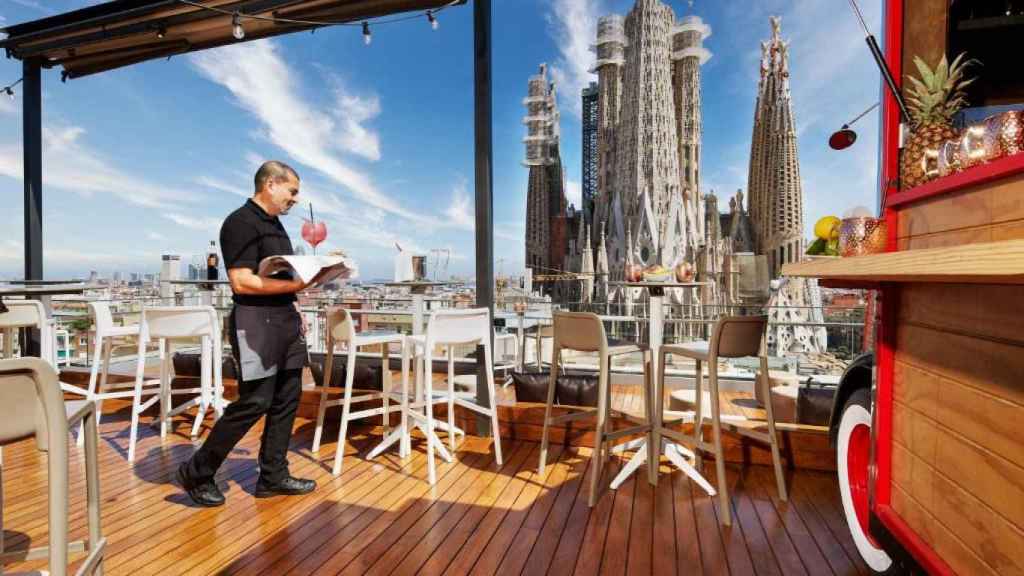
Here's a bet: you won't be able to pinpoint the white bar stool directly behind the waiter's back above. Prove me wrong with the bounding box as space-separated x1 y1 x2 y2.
128 306 225 462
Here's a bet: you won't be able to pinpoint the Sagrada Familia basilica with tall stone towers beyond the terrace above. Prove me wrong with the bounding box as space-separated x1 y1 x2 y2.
526 0 825 352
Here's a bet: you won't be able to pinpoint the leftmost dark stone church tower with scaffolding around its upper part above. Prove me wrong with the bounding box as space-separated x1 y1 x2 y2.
522 65 568 275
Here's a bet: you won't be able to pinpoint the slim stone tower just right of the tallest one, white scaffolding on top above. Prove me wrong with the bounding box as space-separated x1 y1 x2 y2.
672 15 711 260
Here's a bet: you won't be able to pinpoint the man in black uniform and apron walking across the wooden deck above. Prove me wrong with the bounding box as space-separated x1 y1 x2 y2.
177 161 316 506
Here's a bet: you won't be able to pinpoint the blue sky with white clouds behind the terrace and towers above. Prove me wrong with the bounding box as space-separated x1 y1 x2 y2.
0 0 881 278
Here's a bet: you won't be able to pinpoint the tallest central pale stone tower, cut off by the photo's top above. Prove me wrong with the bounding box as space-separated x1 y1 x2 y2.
611 0 686 276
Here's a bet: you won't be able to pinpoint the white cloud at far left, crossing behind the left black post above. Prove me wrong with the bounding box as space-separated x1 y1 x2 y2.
0 122 197 208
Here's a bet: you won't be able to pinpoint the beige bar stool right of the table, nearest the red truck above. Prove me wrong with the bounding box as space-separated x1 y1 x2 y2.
655 316 786 526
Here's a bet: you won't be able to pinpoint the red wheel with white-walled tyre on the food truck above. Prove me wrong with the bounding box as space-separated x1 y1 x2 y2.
836 388 893 574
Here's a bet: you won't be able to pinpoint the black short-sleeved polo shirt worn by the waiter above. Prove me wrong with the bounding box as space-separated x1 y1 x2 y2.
220 199 295 306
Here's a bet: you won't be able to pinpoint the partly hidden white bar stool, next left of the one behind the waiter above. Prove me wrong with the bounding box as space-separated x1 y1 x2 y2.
78 302 144 438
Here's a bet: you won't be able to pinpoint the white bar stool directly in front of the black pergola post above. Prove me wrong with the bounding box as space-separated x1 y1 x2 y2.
406 308 502 485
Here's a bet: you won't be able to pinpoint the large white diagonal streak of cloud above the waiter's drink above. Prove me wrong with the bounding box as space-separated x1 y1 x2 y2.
190 40 433 223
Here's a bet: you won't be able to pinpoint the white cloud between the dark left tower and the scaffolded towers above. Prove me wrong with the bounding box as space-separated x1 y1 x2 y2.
547 0 606 118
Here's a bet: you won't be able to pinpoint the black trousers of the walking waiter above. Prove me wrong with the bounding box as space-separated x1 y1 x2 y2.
187 369 302 484
